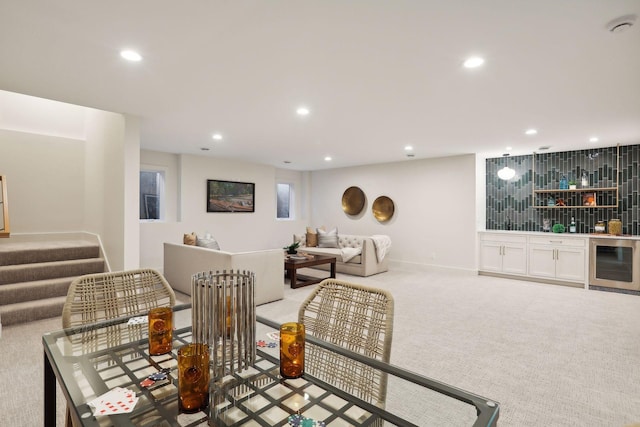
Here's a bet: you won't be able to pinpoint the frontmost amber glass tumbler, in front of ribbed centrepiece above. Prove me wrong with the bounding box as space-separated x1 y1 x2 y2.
178 344 209 412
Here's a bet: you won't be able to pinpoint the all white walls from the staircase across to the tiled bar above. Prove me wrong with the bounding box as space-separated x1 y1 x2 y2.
0 89 482 270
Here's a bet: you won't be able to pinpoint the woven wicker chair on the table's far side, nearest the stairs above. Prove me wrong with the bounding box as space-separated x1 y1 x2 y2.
62 269 176 427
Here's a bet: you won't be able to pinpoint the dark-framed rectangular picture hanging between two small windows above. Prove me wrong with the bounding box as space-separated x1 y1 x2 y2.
207 179 256 212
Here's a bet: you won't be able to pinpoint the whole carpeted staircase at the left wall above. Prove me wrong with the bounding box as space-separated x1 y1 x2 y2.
0 240 105 326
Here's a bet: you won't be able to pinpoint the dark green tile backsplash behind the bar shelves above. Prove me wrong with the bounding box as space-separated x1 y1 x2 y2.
486 145 640 235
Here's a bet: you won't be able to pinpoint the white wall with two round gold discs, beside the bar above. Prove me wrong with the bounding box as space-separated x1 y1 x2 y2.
310 155 477 270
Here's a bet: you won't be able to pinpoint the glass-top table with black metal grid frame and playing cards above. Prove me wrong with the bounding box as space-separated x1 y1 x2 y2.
42 304 500 427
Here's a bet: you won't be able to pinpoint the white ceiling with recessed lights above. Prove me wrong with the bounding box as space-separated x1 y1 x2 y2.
0 0 640 170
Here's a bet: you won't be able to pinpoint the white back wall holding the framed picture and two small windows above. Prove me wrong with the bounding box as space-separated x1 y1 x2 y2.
140 151 308 271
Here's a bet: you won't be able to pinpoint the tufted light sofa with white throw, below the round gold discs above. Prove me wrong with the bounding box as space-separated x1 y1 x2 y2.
293 234 389 277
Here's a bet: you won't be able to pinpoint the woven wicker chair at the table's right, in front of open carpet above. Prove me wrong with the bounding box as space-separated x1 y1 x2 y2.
298 279 393 422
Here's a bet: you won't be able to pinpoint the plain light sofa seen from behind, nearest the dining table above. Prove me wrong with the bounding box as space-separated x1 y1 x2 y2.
163 243 284 305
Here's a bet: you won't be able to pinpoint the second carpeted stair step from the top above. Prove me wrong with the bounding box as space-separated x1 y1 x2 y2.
0 258 104 285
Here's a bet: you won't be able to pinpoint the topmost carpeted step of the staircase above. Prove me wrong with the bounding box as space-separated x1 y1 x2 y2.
0 240 100 266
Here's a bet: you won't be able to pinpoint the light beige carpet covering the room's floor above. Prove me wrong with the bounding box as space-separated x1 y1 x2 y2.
0 268 640 427
